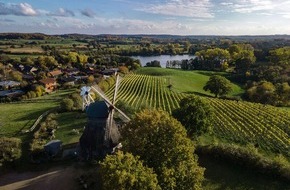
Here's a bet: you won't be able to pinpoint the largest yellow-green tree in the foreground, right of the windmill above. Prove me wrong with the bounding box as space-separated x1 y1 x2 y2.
121 110 204 190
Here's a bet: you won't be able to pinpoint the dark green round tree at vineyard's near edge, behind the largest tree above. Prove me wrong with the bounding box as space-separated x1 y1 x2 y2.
172 96 212 136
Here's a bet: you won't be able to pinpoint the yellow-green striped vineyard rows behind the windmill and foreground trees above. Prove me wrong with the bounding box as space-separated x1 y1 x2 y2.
107 74 290 158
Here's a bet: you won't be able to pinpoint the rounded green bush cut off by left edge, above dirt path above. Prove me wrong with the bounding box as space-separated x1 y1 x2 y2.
0 137 21 166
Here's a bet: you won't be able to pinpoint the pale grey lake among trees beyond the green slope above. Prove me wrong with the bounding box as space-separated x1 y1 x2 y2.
132 54 195 68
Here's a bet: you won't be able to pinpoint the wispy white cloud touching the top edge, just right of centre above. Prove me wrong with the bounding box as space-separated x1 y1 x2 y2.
137 0 214 18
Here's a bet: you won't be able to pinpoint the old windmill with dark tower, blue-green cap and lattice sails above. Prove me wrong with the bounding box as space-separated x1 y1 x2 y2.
79 75 130 160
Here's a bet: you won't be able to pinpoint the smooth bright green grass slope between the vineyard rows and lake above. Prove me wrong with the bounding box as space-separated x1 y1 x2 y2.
137 67 244 96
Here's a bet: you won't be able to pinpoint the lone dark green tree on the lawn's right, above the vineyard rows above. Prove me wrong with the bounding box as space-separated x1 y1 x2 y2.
203 75 232 97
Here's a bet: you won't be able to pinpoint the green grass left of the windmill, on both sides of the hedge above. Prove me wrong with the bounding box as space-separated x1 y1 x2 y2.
0 89 85 143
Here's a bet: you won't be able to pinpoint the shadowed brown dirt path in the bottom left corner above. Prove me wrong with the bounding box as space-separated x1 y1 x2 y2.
0 166 84 190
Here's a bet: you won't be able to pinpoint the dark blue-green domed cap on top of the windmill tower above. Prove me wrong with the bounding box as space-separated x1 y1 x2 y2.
86 101 109 119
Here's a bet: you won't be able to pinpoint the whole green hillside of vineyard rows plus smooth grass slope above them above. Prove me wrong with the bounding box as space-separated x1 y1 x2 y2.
107 68 290 158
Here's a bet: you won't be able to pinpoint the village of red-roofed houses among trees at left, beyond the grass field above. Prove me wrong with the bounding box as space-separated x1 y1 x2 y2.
0 63 123 102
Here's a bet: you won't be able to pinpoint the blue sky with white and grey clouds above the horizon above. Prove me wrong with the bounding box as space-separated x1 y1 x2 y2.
0 0 290 35
